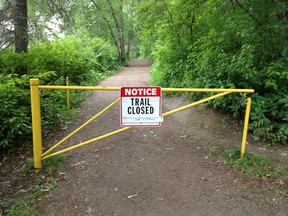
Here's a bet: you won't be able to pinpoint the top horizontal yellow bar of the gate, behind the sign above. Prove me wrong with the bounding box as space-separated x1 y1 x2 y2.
39 85 254 93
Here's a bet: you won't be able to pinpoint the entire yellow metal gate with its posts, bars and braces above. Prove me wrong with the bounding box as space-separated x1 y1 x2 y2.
30 79 254 172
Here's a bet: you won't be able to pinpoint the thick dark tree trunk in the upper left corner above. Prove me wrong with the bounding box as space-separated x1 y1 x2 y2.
14 0 28 53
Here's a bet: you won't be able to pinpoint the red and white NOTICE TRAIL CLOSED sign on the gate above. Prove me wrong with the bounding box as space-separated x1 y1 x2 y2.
120 87 163 127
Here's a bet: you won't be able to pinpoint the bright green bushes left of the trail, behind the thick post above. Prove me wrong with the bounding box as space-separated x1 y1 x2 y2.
0 37 119 150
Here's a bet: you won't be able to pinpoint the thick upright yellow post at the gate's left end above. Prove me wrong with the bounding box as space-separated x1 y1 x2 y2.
30 79 42 172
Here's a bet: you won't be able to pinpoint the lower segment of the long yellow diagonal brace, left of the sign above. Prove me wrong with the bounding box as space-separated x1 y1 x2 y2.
42 127 130 160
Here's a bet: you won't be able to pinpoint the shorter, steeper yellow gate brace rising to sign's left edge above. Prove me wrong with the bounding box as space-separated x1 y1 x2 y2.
42 98 120 157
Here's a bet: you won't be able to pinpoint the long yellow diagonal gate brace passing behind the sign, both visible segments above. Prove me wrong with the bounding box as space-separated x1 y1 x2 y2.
42 92 232 160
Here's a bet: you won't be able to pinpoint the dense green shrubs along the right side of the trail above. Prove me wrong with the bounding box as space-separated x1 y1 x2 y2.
152 43 288 144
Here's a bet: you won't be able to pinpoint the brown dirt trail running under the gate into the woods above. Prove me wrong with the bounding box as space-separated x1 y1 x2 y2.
38 60 288 216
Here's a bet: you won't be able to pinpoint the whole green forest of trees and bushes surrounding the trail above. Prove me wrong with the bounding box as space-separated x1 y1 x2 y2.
0 0 288 155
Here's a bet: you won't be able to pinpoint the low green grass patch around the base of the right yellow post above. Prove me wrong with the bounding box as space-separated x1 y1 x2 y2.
213 149 279 177
